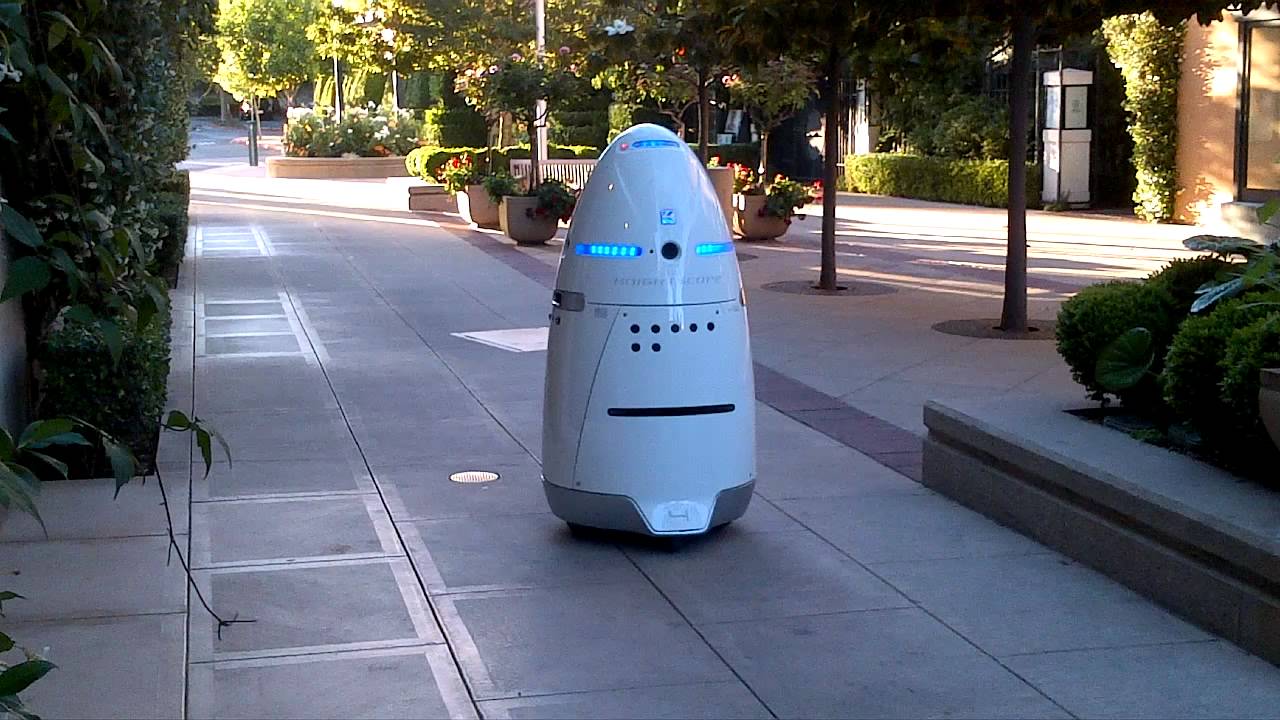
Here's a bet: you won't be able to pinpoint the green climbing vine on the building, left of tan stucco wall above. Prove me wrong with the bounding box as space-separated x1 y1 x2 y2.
1102 12 1187 222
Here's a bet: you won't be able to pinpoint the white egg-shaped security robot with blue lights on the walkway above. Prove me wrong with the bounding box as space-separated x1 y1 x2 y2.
543 124 755 536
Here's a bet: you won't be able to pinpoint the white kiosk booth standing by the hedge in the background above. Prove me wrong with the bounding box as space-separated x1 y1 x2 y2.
1041 68 1093 208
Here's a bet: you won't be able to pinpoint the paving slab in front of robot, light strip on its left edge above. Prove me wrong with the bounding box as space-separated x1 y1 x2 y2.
436 582 732 700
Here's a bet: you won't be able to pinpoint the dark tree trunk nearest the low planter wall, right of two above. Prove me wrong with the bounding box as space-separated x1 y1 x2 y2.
1000 3 1036 333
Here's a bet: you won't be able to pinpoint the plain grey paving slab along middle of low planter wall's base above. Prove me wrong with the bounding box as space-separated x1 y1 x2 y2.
872 553 1211 657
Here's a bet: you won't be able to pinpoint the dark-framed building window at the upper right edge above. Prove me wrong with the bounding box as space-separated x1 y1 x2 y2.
1236 20 1280 201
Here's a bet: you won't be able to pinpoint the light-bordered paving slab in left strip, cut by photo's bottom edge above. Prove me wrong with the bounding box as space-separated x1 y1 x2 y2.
189 646 476 720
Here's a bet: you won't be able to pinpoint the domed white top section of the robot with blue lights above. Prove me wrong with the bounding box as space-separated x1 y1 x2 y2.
556 124 741 305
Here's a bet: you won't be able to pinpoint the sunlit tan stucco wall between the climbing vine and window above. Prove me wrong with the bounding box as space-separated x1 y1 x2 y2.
1178 15 1240 223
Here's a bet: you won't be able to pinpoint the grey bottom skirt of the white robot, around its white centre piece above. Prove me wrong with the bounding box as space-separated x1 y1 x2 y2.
543 480 755 537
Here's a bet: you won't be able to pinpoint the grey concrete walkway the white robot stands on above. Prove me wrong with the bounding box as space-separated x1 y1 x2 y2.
10 163 1280 717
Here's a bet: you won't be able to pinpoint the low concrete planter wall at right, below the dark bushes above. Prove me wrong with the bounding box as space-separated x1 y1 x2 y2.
923 398 1280 664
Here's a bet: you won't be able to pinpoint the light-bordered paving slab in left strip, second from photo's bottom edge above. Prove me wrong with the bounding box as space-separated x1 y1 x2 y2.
191 559 443 662
